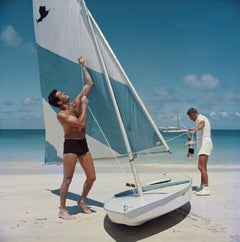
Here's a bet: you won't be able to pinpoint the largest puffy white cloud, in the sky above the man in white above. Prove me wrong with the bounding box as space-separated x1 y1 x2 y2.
184 74 219 90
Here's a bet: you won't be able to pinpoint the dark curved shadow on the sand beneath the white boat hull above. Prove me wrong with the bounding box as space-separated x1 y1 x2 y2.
104 202 191 242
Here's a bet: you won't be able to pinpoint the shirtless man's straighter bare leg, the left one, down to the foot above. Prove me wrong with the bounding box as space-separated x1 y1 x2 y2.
58 154 77 219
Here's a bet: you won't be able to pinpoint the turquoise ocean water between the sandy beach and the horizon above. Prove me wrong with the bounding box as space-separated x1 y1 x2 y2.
0 130 240 165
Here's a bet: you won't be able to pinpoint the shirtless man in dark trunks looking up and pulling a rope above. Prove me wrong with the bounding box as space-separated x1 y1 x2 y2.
48 57 96 219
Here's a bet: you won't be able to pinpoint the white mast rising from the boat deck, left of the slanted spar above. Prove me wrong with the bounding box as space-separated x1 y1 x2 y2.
81 0 143 196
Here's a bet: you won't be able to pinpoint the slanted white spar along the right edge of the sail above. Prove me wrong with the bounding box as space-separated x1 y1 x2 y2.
89 12 170 152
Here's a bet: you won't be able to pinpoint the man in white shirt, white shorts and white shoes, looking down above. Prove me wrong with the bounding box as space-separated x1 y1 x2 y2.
187 108 213 196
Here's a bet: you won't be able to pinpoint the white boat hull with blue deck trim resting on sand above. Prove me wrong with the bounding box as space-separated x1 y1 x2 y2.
104 175 192 226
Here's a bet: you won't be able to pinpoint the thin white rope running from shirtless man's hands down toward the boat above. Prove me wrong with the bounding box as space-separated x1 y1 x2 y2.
82 68 136 194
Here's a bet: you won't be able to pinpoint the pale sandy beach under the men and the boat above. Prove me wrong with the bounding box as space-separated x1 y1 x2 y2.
0 162 240 242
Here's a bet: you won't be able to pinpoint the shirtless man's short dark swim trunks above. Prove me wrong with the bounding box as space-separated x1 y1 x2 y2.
63 139 89 156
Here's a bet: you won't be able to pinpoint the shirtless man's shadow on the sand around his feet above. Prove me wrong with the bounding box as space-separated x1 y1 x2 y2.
48 189 104 215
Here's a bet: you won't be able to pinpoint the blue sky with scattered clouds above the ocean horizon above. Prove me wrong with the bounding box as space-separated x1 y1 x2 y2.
0 0 240 129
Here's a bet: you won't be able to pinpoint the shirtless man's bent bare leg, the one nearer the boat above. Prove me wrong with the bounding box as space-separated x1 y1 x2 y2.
78 152 96 214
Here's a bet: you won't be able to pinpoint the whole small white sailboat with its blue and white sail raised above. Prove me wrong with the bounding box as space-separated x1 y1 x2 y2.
33 0 191 226
